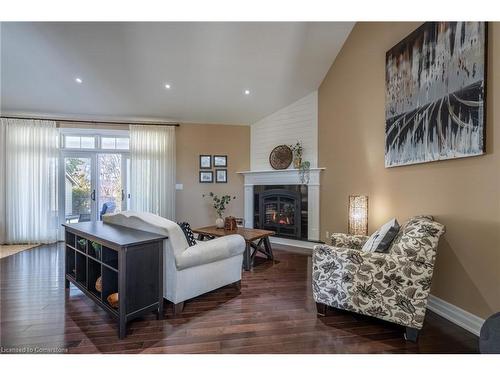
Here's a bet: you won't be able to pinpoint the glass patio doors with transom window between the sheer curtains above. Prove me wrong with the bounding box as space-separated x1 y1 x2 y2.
58 132 130 233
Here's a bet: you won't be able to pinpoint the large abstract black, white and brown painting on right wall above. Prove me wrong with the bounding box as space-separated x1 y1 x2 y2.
385 22 487 167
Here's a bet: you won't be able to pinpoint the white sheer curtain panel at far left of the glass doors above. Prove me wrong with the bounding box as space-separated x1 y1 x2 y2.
0 119 59 243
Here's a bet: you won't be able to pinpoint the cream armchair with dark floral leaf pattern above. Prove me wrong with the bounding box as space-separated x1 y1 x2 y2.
312 216 445 341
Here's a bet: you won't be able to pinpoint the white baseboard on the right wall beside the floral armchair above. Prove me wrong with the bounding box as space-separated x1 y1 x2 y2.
427 294 484 336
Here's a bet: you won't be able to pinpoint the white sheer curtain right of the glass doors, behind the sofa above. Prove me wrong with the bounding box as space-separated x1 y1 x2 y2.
130 125 175 220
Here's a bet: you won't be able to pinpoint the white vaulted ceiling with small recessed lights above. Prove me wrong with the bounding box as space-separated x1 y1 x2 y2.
0 22 353 124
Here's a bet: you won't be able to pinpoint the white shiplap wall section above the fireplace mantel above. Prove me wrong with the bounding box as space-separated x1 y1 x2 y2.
250 91 318 171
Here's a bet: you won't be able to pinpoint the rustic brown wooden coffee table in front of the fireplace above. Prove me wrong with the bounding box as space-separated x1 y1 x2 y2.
193 225 274 271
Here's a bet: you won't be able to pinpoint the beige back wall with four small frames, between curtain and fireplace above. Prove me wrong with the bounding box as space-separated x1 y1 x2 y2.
175 124 250 227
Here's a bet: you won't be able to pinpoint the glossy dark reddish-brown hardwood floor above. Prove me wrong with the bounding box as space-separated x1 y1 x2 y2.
0 245 478 353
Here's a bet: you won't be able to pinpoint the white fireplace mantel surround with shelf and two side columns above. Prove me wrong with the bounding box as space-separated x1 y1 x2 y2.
237 168 325 241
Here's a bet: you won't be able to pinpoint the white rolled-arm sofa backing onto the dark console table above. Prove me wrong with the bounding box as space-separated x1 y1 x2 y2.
103 211 245 315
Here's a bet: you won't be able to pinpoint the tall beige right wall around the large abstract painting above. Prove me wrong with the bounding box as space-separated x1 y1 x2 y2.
318 23 500 318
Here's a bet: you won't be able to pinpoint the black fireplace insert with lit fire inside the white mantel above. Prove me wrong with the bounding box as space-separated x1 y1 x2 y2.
254 185 307 240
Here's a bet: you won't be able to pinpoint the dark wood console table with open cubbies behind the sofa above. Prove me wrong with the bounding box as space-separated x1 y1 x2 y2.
63 222 167 339
